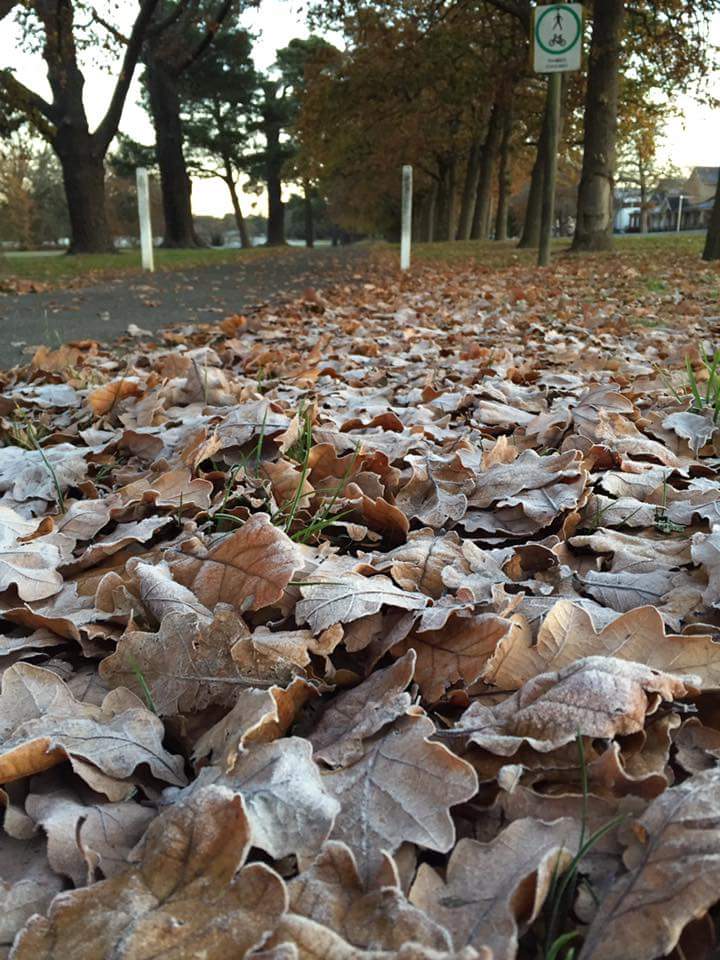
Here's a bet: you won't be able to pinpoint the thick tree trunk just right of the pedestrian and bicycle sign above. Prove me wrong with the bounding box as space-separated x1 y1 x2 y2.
572 0 625 250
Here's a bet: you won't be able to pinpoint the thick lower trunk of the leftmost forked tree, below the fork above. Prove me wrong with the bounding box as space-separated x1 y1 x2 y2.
53 137 115 253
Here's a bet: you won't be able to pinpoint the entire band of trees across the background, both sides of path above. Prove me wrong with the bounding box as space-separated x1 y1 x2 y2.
0 0 720 258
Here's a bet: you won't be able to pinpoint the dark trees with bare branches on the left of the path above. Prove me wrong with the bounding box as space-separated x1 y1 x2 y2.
0 0 330 253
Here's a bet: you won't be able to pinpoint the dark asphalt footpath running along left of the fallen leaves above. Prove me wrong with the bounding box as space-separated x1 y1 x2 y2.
0 247 368 369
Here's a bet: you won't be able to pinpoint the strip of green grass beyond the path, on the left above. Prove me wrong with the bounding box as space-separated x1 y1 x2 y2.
0 247 296 286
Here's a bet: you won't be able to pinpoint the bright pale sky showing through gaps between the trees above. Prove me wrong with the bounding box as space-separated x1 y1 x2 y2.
2 0 720 216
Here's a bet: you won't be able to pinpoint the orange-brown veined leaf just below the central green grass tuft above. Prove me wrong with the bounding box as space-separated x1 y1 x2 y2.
169 513 300 612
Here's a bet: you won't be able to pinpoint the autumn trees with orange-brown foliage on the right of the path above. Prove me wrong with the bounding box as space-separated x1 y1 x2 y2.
299 0 720 256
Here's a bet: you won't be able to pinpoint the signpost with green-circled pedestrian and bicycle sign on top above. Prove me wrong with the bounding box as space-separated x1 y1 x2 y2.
531 3 583 267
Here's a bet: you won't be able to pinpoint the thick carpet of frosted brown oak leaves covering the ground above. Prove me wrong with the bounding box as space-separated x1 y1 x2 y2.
0 249 720 960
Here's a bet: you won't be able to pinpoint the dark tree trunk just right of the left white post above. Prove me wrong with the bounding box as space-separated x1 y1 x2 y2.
145 53 202 247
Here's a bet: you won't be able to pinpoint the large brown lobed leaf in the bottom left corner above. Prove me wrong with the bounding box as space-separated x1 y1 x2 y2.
13 787 287 960
